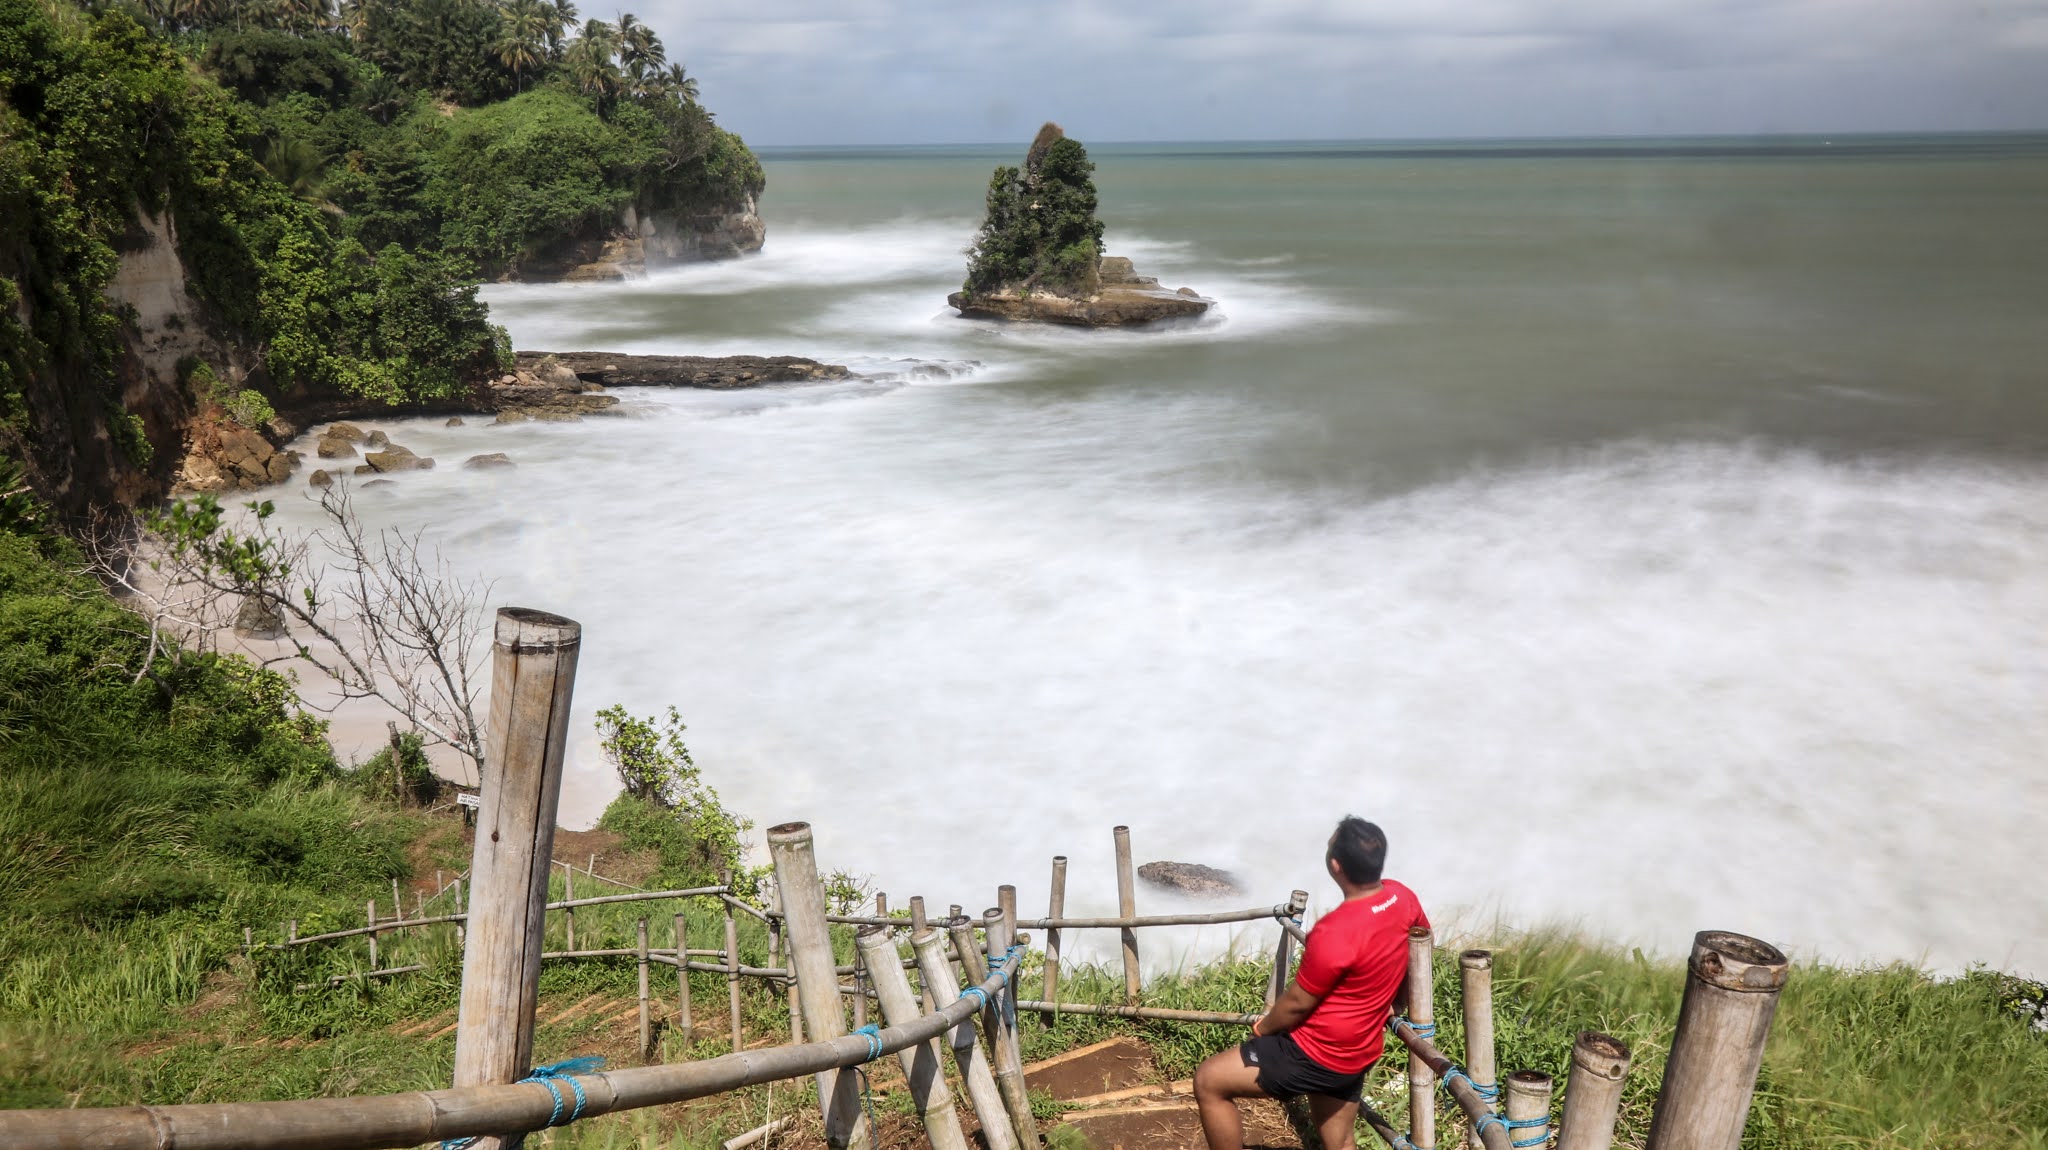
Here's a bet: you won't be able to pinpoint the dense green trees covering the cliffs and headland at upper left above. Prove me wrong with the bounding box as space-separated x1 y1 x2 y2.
0 0 762 487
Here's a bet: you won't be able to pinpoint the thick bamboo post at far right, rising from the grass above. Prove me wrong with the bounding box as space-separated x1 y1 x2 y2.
1649 931 1790 1150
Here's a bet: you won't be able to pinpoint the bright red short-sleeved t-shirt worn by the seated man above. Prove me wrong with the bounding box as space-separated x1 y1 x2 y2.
1290 880 1430 1074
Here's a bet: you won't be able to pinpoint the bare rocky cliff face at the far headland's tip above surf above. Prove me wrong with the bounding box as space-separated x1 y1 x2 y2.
506 196 768 282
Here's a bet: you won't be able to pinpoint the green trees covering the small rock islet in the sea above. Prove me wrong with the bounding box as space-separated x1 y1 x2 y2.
967 125 1102 297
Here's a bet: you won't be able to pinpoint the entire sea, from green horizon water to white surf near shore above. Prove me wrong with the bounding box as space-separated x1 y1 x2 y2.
283 137 2048 974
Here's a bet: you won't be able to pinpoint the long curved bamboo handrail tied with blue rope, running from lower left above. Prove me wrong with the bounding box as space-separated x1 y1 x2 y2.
0 945 1032 1150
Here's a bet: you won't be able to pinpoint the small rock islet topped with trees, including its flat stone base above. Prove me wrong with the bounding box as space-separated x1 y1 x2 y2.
946 123 1210 327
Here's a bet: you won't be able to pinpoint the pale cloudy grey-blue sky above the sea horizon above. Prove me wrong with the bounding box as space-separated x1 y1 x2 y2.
622 0 2048 145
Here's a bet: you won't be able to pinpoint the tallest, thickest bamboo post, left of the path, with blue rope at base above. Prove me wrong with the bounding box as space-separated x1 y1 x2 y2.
455 608 584 1150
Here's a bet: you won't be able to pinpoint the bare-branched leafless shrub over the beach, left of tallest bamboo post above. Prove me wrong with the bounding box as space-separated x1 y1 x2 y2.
88 485 492 780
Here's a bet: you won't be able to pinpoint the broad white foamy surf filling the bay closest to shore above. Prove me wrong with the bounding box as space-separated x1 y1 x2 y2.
268 387 2048 970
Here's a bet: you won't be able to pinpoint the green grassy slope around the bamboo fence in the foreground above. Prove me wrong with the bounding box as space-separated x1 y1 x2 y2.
0 534 2048 1148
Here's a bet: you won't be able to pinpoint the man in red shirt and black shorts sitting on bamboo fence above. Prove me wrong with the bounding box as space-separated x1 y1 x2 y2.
1194 816 1430 1150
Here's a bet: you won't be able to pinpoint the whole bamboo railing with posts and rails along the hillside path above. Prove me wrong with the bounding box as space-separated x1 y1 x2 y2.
0 610 1788 1150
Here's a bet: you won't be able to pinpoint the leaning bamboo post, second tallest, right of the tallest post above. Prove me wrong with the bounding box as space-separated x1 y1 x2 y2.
768 823 870 1150
